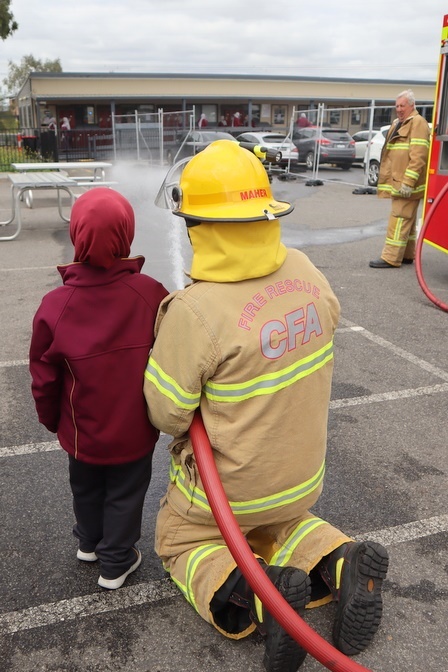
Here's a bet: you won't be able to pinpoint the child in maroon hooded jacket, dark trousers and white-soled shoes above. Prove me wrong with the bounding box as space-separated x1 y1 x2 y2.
30 187 168 589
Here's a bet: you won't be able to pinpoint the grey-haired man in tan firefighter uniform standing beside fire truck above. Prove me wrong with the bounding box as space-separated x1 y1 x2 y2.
369 89 429 268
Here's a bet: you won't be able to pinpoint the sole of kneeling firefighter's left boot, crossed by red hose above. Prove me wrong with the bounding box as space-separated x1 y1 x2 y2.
263 567 311 672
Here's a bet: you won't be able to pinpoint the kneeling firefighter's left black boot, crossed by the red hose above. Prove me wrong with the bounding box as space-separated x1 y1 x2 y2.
231 563 311 672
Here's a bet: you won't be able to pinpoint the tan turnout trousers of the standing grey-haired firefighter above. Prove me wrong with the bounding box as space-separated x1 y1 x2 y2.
381 198 420 267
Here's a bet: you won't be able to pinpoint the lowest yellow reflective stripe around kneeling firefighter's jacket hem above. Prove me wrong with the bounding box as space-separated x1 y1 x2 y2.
170 460 325 516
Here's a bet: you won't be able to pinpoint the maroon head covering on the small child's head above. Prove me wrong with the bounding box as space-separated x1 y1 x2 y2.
70 187 135 269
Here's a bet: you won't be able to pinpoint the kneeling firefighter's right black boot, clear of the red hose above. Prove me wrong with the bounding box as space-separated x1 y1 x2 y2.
317 541 389 656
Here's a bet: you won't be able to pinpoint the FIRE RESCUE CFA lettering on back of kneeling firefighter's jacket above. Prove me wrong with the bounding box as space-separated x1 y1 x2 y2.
238 278 322 359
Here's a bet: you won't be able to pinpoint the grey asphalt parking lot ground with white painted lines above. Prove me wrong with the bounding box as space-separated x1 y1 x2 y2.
0 166 448 672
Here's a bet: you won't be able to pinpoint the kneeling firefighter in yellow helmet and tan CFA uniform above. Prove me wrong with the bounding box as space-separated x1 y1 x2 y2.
144 140 388 672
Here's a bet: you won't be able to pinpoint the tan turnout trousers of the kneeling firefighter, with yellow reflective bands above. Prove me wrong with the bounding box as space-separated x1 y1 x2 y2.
155 485 352 639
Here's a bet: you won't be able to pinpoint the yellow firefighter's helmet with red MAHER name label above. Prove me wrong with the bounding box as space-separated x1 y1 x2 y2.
171 140 293 224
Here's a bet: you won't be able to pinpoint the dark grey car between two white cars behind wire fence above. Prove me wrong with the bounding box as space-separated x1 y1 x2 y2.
292 126 356 170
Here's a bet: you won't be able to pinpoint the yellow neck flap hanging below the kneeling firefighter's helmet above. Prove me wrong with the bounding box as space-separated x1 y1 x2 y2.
188 219 286 282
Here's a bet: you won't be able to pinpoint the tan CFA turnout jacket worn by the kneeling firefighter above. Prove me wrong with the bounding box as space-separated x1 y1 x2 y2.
144 249 340 524
